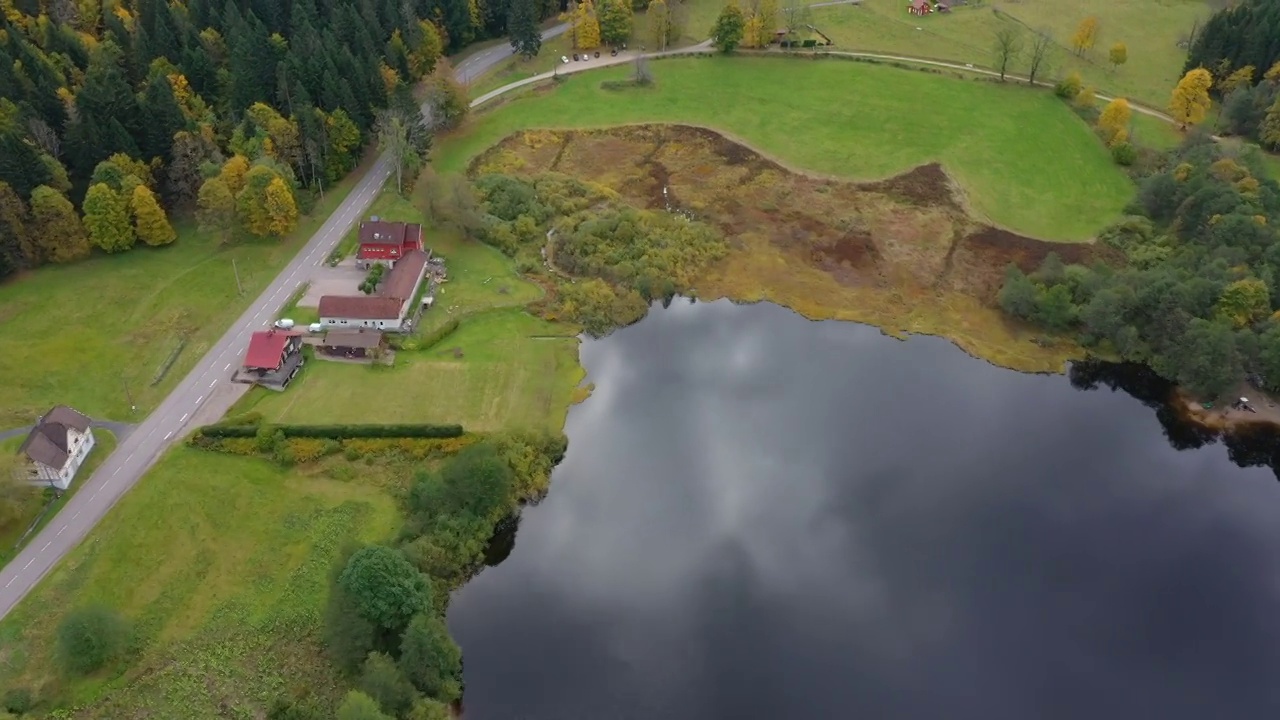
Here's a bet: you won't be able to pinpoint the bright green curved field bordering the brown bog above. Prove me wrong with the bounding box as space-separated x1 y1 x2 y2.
435 56 1133 241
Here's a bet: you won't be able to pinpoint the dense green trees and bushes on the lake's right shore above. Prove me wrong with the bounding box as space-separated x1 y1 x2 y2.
1000 133 1280 398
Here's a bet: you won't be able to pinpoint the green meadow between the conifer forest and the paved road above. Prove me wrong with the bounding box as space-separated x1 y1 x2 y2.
0 148 367 428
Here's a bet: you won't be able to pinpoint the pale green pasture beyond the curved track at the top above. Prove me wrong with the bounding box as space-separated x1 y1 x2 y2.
808 0 1212 110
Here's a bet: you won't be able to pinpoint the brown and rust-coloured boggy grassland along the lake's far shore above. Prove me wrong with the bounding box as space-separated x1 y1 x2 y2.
471 124 1103 372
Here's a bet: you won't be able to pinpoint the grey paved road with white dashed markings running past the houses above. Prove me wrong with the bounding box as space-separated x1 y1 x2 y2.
0 26 566 618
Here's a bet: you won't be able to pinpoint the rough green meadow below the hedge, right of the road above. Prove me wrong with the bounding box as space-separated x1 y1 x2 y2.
0 447 396 720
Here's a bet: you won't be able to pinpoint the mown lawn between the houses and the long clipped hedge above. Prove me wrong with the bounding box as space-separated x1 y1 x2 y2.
244 307 584 432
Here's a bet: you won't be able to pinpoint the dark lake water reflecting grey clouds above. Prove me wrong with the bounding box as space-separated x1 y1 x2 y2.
449 294 1280 720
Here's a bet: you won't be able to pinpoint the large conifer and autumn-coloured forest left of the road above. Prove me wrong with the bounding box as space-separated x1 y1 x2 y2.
0 0 558 278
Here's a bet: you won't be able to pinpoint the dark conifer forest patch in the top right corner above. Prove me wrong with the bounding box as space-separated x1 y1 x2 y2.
1185 0 1280 150
